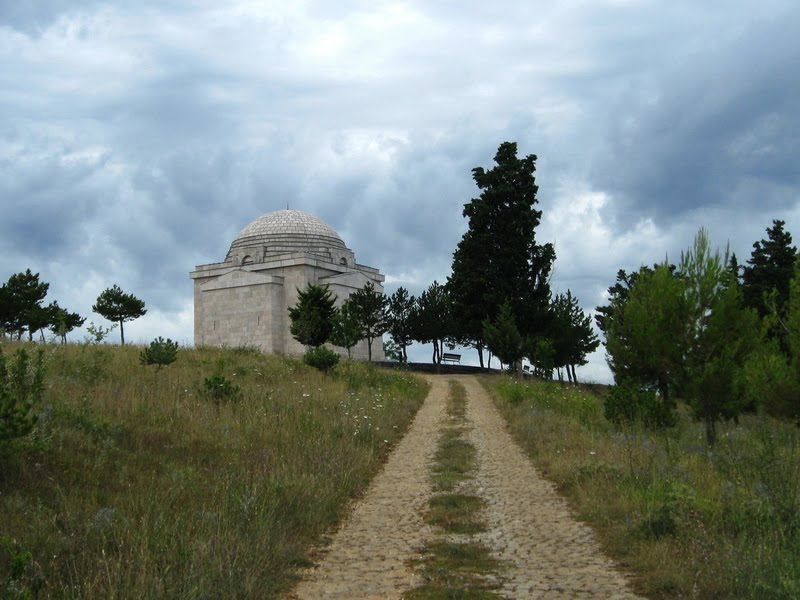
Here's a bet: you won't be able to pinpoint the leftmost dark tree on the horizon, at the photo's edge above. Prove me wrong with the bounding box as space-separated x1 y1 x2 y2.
0 269 50 339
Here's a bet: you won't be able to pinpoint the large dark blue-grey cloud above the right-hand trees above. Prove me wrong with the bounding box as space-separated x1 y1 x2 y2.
595 10 800 223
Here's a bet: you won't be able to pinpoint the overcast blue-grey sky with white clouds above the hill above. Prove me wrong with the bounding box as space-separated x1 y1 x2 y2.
0 0 800 380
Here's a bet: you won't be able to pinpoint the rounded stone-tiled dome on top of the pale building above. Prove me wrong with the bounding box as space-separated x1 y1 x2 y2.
228 210 347 256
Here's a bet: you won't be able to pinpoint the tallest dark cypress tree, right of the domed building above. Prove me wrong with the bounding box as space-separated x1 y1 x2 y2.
447 142 555 366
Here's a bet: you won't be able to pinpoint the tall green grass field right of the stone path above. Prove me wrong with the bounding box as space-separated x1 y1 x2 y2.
484 378 800 600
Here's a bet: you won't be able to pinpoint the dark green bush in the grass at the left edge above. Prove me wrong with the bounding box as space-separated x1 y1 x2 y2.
0 348 44 444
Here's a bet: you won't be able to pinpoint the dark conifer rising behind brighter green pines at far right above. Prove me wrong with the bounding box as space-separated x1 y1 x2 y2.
742 220 797 317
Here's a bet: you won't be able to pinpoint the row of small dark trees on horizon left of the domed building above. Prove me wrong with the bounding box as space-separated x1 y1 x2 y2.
0 269 147 345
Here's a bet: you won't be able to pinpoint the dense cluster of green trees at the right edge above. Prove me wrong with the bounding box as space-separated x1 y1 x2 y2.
595 220 800 445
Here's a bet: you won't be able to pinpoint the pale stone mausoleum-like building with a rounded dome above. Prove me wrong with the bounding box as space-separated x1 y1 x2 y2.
189 210 385 360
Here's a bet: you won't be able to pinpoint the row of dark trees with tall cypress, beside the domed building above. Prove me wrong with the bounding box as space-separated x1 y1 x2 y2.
290 142 600 381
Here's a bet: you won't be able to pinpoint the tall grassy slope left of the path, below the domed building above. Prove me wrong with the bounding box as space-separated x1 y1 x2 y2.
0 345 426 599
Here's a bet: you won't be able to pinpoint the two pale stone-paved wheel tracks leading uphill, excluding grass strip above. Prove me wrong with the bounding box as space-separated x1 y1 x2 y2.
290 376 636 600
